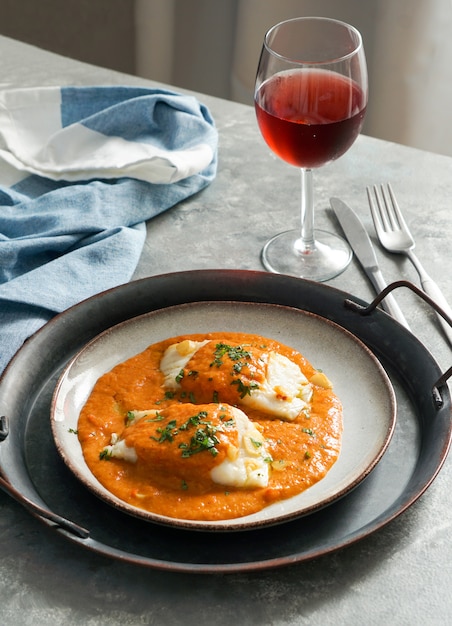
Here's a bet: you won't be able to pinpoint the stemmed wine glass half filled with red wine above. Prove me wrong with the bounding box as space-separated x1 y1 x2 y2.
254 17 368 281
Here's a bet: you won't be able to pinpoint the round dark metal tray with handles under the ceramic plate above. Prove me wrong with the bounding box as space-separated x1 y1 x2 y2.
0 270 451 573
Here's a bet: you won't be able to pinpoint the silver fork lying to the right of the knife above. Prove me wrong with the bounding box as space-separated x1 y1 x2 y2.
367 184 452 344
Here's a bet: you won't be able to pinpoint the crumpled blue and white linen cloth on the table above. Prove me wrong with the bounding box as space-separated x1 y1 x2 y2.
0 86 218 373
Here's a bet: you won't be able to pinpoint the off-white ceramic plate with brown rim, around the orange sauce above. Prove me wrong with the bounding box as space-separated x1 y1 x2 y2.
51 301 396 531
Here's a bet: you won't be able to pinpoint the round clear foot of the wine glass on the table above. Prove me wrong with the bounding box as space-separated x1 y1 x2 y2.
262 230 352 282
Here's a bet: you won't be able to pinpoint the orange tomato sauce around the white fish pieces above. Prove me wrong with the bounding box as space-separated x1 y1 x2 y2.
78 333 342 521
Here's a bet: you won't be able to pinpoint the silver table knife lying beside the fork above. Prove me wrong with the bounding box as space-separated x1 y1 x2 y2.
330 198 410 330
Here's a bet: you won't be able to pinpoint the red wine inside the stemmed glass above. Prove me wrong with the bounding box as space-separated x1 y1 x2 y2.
255 69 366 168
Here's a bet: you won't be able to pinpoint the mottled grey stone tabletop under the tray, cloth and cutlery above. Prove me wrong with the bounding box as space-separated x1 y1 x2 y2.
0 37 452 626
